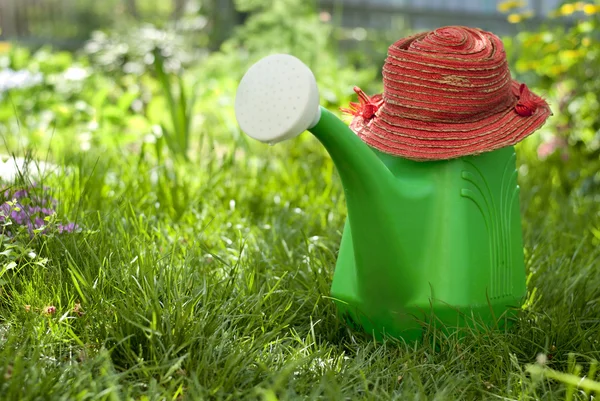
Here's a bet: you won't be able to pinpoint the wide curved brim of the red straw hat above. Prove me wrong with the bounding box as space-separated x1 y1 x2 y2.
350 80 552 161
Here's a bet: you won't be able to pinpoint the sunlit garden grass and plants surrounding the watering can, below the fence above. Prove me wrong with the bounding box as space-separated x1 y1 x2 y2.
0 0 600 401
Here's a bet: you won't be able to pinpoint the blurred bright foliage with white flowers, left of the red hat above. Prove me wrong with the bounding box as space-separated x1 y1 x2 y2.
0 0 380 163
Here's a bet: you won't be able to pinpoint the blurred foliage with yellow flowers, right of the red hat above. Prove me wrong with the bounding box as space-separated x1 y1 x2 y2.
506 1 600 196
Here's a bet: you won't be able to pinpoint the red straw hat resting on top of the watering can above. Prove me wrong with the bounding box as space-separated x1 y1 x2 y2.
342 26 552 160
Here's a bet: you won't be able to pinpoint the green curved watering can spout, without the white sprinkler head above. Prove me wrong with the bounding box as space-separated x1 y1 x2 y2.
309 108 418 313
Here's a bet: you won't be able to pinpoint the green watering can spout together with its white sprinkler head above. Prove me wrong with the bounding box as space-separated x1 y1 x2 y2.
235 55 422 332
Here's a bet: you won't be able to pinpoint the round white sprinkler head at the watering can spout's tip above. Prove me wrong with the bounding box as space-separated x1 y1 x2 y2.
235 54 321 144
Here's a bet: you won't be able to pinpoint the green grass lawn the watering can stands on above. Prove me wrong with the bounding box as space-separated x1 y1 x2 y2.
0 134 600 401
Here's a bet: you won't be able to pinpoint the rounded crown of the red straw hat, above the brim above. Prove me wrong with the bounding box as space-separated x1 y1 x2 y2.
382 26 515 122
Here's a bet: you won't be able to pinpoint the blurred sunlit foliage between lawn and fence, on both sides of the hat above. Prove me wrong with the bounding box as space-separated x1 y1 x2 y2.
0 0 600 203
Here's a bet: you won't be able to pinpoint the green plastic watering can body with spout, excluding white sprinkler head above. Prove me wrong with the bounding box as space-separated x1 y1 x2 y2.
311 108 526 340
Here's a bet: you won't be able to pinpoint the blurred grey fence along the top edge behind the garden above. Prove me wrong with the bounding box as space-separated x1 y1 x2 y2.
0 0 561 47
